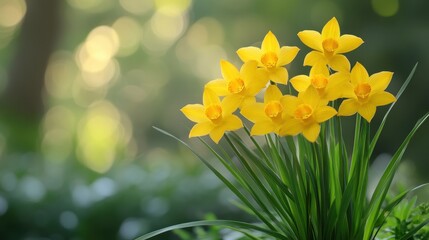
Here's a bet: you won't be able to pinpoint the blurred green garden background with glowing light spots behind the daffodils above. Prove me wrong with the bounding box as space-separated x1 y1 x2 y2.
0 0 429 239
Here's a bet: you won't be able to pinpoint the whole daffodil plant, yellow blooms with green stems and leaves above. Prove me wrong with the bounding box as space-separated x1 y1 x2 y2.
139 18 429 240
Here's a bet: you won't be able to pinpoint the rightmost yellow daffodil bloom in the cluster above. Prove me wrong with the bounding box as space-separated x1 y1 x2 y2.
338 63 396 122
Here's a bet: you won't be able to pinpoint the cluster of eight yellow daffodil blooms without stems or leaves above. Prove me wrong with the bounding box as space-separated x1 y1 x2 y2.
181 18 396 143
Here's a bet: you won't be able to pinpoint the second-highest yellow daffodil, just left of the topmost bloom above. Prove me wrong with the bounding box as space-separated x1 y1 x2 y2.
237 31 299 84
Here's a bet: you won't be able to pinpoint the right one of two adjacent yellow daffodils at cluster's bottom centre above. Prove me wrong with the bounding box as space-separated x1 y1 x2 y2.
279 88 337 142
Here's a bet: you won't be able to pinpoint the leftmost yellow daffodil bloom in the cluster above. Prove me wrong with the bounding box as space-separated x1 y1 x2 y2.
180 89 243 143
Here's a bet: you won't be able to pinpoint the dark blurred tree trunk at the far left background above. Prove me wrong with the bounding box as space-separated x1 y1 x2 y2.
0 0 62 150
